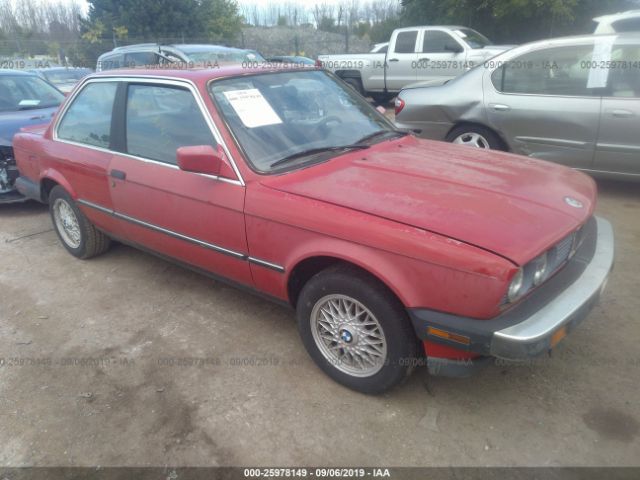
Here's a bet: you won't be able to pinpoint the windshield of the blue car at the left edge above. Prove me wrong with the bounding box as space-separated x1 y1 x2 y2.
0 75 64 112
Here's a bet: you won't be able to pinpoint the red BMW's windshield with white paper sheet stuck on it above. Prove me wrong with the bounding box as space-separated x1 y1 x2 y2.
209 70 399 172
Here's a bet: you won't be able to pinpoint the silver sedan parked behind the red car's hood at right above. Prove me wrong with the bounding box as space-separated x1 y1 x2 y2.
395 34 640 179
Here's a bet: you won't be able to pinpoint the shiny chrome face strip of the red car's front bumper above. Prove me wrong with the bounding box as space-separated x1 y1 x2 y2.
490 217 615 358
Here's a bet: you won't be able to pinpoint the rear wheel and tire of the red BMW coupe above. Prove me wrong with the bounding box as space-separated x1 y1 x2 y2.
49 185 111 259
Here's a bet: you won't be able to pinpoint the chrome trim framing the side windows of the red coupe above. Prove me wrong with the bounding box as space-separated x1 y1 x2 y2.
52 75 245 186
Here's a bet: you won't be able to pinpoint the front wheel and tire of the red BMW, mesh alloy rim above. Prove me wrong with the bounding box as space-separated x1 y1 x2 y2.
296 266 419 394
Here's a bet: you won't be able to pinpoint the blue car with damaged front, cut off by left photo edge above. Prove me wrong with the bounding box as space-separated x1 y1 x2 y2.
0 70 64 204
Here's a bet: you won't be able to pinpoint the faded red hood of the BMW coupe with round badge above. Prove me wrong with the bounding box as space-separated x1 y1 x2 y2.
261 137 596 265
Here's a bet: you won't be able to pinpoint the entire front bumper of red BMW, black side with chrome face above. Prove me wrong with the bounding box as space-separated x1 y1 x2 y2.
409 217 614 360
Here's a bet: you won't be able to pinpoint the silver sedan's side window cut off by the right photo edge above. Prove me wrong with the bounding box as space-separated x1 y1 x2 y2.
608 45 640 98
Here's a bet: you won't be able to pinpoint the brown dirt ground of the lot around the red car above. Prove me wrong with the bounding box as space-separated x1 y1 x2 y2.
0 177 640 466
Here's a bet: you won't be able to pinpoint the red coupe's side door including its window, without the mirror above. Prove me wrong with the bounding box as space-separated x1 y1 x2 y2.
109 81 252 285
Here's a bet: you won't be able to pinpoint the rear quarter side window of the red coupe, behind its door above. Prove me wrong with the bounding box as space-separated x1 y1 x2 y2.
57 82 117 148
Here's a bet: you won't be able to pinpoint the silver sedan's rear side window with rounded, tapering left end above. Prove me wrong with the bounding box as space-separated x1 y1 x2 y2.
491 45 594 96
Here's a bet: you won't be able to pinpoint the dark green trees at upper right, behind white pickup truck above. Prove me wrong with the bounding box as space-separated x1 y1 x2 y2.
402 0 637 43
